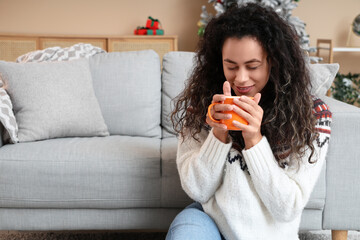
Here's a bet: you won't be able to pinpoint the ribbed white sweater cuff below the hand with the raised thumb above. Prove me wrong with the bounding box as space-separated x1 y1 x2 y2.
200 129 232 167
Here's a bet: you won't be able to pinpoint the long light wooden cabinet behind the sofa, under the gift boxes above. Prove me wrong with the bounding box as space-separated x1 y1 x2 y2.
0 34 177 61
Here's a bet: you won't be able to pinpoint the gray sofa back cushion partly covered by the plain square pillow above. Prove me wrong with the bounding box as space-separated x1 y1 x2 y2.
90 50 161 138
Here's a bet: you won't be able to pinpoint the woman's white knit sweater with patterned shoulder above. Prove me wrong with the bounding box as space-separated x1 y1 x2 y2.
177 100 331 240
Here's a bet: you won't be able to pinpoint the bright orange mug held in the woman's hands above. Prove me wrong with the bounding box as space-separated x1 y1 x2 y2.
208 96 254 131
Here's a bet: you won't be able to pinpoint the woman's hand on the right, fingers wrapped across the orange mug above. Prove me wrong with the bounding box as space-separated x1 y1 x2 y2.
233 93 264 149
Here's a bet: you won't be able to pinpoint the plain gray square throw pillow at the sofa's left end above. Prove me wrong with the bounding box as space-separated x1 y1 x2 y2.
0 59 109 142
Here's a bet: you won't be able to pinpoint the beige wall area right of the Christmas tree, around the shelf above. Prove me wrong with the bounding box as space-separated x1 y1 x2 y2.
293 0 360 74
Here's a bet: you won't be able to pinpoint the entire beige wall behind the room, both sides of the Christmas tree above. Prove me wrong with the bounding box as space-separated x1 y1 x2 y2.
0 0 360 73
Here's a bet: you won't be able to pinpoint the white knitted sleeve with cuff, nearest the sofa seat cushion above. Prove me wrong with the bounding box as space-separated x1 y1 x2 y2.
176 130 232 203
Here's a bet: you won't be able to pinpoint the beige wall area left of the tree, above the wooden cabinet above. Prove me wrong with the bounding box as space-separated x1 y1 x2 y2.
0 0 207 51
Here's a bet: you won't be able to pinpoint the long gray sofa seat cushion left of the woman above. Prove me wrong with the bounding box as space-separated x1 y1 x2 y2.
0 136 160 208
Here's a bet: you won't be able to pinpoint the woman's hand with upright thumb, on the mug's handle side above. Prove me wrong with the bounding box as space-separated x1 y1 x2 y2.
206 81 234 143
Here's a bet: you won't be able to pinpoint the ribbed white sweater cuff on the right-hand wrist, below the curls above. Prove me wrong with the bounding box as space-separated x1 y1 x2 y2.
242 136 279 176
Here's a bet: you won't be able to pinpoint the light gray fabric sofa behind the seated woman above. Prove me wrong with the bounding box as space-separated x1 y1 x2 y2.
0 50 360 237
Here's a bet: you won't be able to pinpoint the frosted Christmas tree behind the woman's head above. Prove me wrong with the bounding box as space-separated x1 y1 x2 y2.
198 0 321 62
